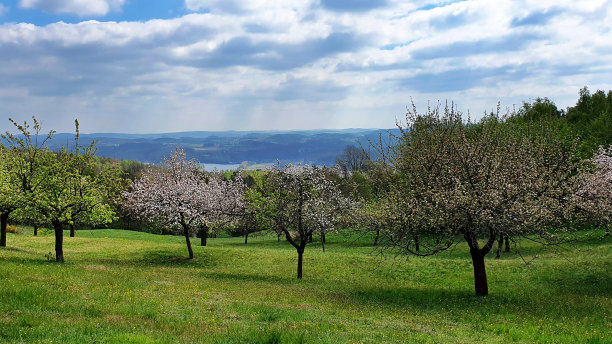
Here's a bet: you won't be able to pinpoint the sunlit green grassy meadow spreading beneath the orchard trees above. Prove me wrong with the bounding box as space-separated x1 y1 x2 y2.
0 229 612 343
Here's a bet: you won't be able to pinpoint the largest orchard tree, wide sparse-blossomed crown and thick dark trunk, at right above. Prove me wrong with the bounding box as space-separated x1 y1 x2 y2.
376 105 576 296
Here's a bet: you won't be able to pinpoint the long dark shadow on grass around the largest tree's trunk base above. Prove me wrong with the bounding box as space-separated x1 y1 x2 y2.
342 270 612 318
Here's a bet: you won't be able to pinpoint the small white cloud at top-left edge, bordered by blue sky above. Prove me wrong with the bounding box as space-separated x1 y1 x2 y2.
19 0 125 17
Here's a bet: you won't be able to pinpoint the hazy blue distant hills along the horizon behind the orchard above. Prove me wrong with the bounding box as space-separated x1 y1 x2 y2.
43 129 397 165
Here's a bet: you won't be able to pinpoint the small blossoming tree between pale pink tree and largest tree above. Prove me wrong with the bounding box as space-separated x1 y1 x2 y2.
267 165 353 279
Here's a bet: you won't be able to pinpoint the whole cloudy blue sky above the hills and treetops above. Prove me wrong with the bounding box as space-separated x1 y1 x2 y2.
0 0 612 133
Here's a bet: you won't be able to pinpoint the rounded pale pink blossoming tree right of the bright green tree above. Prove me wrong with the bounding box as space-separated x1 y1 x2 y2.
122 148 244 259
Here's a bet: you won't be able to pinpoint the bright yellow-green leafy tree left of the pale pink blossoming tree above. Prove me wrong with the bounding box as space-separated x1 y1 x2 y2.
3 117 113 263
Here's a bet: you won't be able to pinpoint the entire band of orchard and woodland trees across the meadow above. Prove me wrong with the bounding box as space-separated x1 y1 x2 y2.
0 88 612 295
